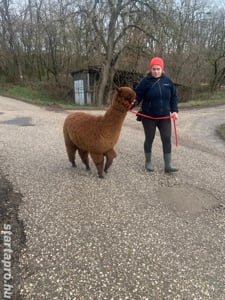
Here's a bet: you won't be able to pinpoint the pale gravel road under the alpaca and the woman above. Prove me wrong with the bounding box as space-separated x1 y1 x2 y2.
0 97 225 300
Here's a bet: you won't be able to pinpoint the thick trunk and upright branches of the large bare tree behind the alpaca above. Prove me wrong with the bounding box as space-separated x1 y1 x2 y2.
86 0 139 105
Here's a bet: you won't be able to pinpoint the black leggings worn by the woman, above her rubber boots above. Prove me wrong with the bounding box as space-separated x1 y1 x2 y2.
142 118 171 153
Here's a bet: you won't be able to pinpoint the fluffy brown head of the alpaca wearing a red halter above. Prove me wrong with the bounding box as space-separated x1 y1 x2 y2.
112 86 136 112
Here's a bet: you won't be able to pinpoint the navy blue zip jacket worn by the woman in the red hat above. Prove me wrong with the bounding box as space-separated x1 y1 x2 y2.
135 74 178 117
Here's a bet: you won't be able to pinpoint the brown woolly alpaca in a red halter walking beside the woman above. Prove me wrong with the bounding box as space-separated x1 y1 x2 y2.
63 87 136 178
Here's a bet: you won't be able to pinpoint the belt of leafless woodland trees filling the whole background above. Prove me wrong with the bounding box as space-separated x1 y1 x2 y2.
0 0 225 105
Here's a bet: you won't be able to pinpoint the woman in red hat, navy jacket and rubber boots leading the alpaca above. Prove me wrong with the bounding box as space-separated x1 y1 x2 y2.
135 57 178 173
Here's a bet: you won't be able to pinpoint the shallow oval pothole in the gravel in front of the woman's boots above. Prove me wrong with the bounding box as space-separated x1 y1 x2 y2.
157 185 219 213
